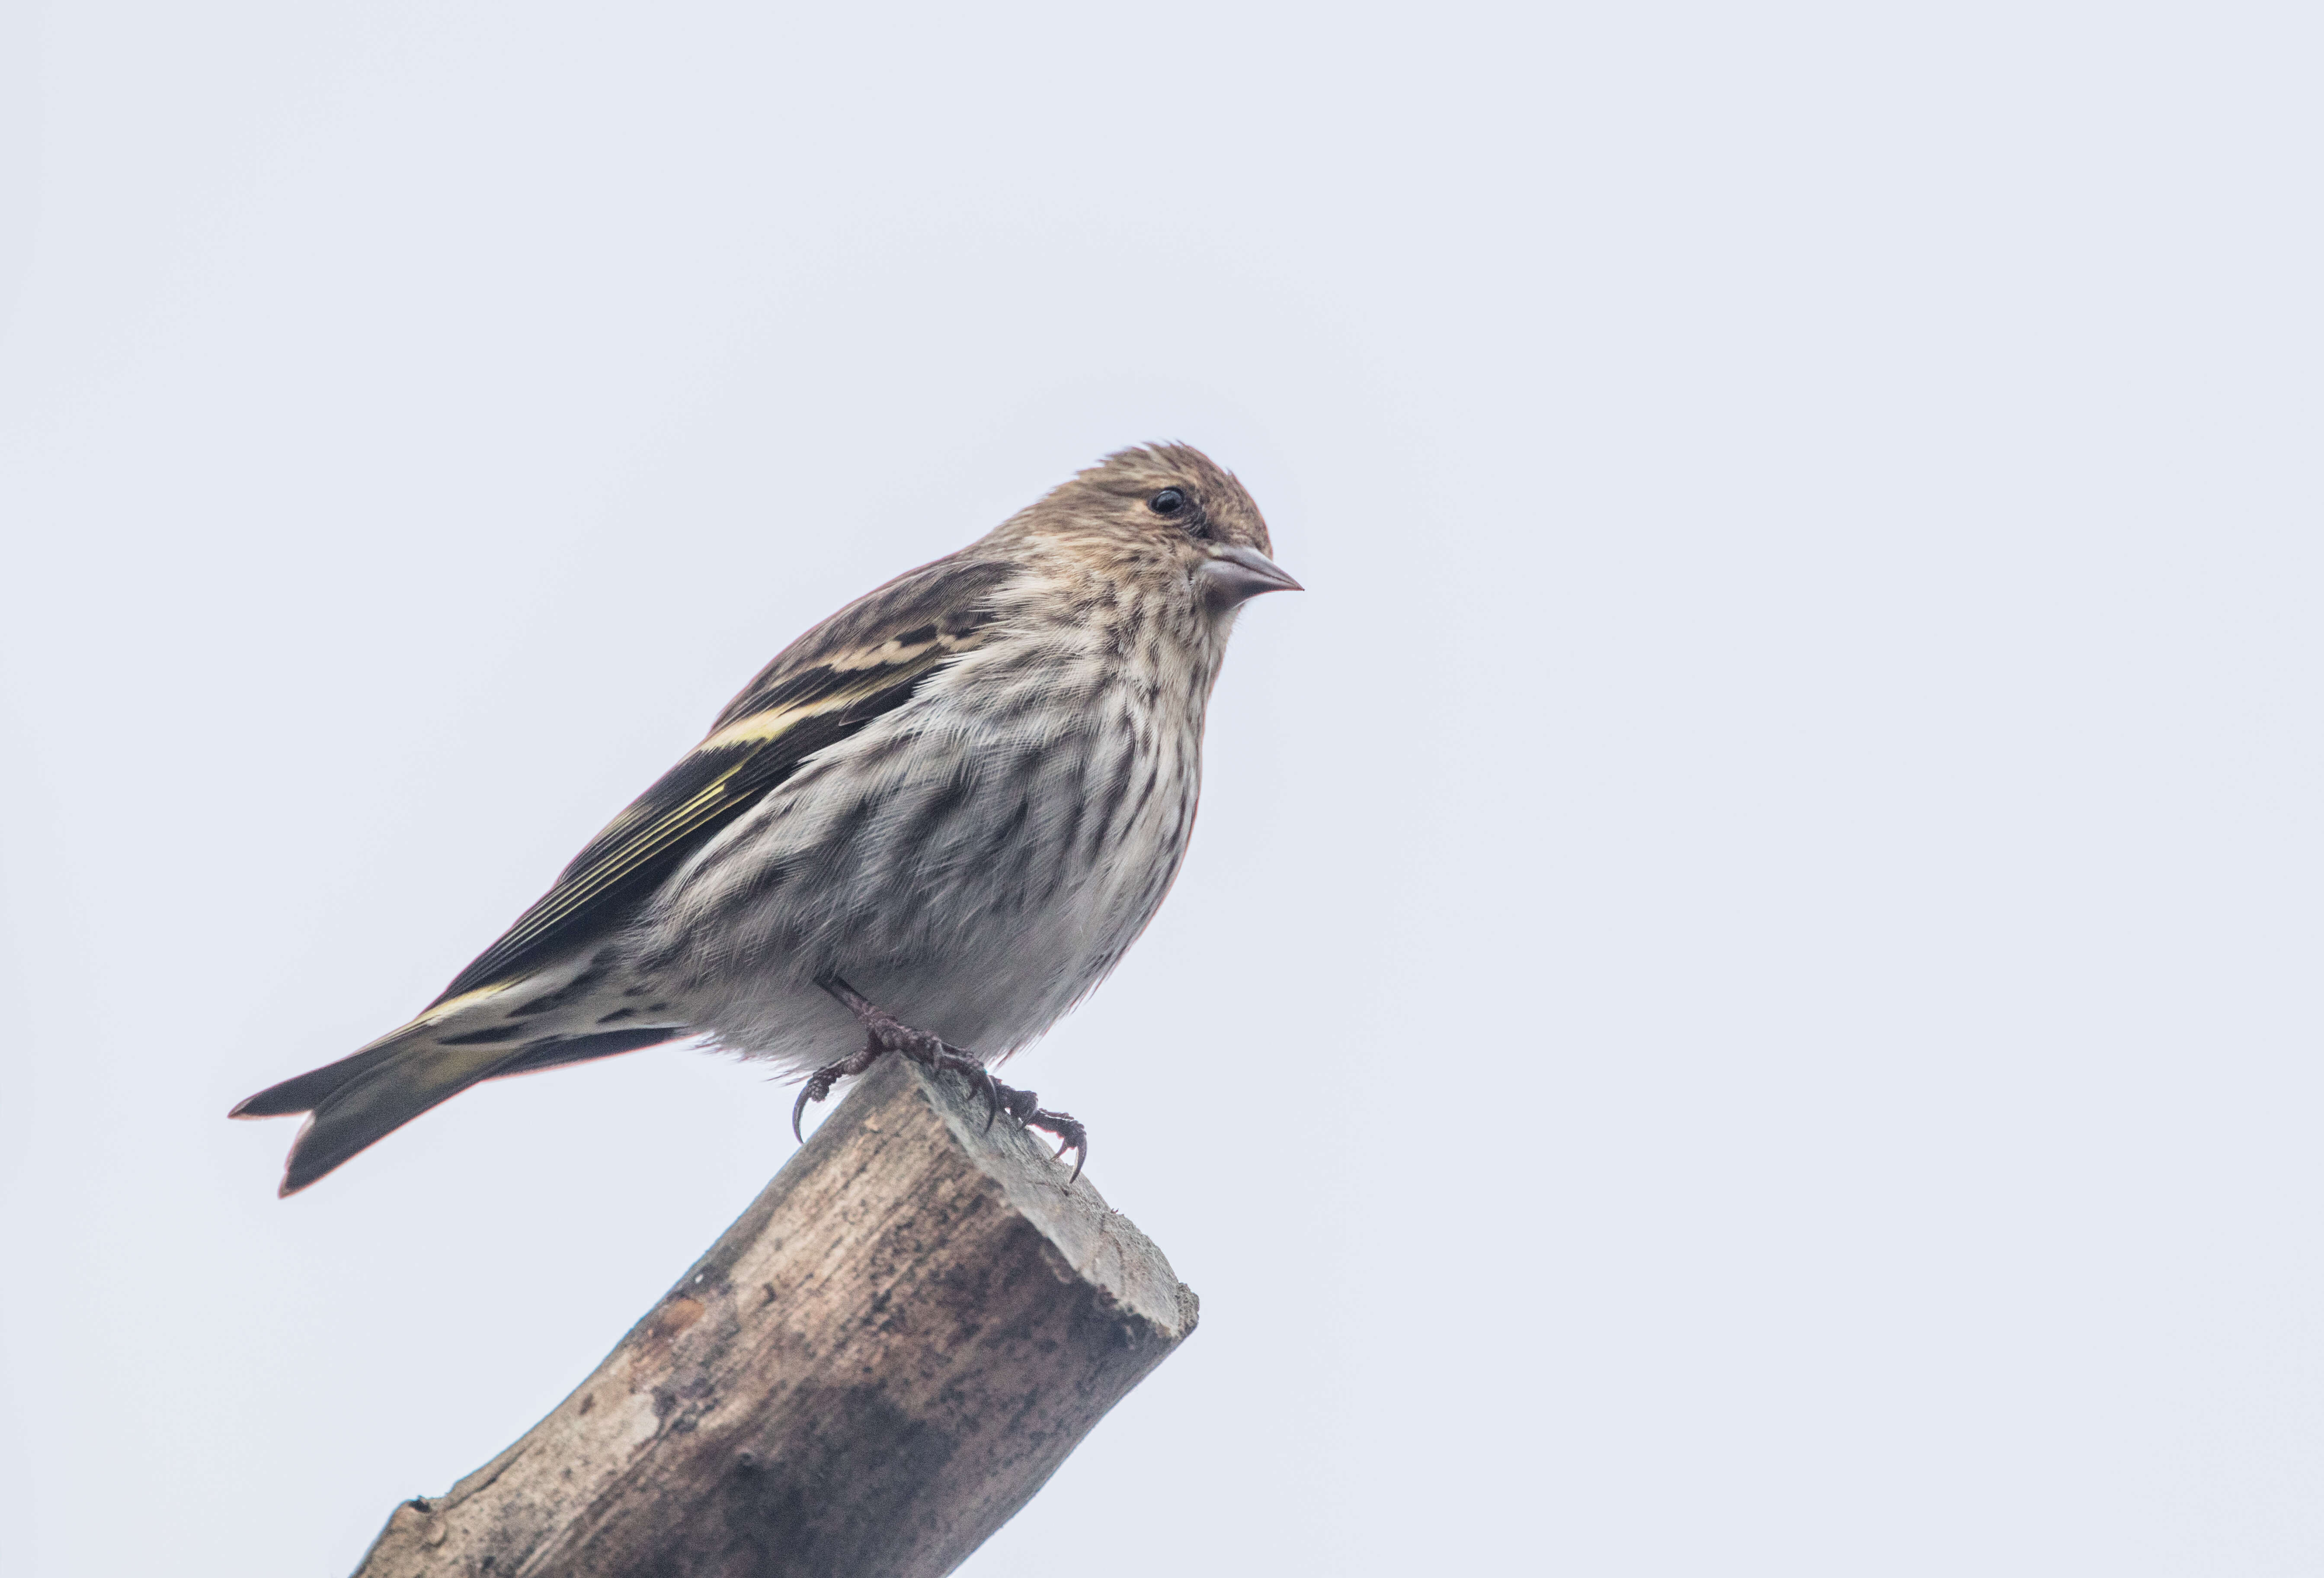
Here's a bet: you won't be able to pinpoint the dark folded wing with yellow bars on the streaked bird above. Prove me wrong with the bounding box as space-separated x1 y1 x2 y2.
430 555 1011 1009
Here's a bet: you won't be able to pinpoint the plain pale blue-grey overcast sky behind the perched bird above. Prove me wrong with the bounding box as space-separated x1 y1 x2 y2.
0 0 2324 1578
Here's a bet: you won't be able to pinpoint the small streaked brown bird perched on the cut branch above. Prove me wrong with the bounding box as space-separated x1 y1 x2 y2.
230 444 1301 1197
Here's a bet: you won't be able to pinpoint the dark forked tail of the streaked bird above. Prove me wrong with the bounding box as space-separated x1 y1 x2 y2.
228 1018 685 1195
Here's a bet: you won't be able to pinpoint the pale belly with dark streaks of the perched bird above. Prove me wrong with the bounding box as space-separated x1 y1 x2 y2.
639 711 1199 1069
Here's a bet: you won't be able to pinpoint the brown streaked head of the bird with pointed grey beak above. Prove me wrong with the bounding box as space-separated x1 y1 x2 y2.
1002 444 1301 611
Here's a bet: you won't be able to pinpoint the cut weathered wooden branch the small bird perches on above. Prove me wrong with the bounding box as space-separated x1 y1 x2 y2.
355 1058 1197 1578
